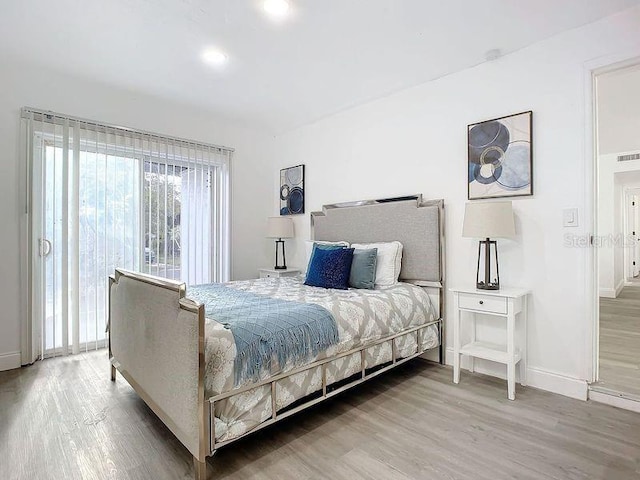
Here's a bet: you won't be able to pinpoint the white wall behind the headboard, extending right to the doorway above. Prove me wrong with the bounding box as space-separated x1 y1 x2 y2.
273 8 640 398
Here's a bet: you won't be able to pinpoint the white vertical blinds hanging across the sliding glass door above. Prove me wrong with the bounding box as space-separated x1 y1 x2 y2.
22 108 233 357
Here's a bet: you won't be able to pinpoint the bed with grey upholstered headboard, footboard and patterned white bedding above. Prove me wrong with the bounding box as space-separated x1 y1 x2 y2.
109 195 444 479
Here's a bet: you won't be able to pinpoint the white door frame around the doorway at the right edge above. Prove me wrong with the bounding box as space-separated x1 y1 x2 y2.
583 47 640 383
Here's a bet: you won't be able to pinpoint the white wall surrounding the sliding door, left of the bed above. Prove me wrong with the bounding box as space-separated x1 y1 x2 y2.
0 58 274 370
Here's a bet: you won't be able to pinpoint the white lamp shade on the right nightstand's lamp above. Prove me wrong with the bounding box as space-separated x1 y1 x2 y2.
462 202 516 238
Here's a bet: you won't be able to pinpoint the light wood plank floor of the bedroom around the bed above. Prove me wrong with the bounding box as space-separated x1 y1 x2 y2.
0 351 640 480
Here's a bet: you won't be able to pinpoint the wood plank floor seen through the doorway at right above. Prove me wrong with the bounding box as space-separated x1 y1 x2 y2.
598 286 640 399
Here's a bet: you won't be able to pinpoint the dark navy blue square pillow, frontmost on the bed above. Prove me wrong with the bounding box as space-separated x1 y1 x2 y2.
304 245 353 290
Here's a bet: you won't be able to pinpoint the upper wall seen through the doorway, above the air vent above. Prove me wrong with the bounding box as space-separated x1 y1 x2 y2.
598 66 640 155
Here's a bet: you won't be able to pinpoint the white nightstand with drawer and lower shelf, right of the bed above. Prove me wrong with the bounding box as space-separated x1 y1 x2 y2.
451 288 530 400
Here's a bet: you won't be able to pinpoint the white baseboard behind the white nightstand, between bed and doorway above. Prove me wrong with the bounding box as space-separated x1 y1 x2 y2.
447 348 589 400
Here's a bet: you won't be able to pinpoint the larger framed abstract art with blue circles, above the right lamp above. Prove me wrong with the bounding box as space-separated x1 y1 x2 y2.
467 111 533 200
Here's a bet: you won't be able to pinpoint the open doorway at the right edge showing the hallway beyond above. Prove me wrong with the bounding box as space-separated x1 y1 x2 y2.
591 64 640 402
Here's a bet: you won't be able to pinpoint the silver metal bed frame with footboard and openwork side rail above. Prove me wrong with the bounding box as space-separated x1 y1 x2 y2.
108 195 445 480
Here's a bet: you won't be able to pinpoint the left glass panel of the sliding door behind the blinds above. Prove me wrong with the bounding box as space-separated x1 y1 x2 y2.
34 140 141 356
